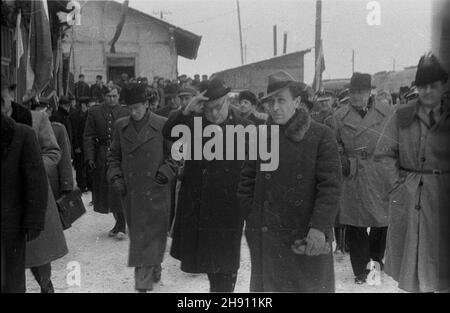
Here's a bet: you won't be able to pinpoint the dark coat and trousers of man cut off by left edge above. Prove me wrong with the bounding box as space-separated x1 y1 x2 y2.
1 113 48 293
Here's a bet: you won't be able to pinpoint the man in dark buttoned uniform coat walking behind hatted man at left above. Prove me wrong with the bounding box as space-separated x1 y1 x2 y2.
84 86 129 239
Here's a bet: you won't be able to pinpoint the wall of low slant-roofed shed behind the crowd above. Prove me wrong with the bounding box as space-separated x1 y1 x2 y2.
214 52 304 95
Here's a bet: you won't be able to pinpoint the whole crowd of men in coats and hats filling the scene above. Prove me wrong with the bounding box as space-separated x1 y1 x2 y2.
1 54 450 292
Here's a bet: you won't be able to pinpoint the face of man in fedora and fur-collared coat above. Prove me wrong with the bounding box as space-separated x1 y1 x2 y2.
267 88 300 125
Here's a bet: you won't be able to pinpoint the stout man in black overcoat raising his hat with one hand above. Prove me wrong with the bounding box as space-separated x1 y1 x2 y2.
163 77 250 292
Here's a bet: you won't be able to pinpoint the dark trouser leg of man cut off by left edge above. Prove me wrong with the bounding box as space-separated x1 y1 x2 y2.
1 231 26 293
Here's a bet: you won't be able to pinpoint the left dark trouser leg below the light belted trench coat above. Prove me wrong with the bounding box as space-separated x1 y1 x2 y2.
346 225 370 276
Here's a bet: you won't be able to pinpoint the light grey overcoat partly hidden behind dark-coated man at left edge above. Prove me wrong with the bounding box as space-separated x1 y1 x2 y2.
25 111 68 268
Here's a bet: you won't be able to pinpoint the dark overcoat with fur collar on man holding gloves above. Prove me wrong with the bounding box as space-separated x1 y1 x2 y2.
238 109 341 292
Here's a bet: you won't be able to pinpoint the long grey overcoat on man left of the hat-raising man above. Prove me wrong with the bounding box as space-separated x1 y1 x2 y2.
107 113 176 267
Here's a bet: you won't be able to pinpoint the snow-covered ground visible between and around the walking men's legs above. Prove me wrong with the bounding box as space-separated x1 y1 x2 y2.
27 193 401 293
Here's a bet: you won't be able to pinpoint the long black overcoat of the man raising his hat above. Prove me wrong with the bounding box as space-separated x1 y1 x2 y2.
163 110 249 273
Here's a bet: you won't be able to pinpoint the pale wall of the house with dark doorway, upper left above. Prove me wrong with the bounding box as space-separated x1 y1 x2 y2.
65 1 178 82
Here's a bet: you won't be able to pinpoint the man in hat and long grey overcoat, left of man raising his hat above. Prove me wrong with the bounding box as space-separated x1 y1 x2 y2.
107 84 177 291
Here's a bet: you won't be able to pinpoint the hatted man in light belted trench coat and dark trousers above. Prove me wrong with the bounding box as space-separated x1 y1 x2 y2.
335 73 392 284
